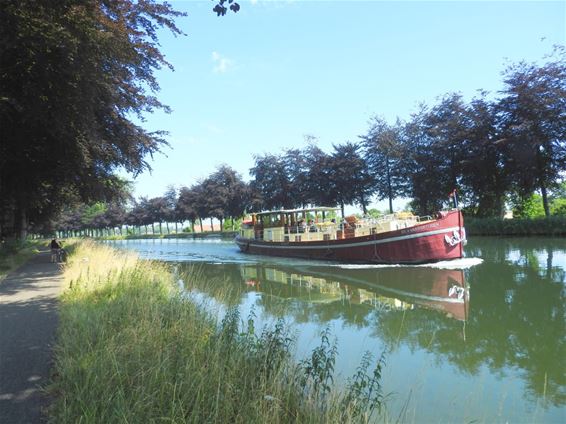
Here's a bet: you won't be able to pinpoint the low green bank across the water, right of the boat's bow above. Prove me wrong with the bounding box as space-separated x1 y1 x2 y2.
464 216 566 236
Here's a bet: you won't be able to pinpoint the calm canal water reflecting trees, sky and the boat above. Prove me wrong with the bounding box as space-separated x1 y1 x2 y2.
109 237 566 423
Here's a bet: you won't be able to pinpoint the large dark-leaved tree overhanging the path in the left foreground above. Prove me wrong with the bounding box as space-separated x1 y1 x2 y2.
0 0 183 236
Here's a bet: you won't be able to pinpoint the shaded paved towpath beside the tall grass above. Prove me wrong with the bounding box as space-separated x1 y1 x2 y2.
0 251 63 424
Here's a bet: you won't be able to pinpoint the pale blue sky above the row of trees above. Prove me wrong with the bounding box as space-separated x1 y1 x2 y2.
125 0 566 208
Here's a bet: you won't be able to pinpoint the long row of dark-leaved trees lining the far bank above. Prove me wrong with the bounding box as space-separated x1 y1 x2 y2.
0 34 566 238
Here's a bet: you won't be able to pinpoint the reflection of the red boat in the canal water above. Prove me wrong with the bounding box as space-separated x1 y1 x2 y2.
241 264 469 321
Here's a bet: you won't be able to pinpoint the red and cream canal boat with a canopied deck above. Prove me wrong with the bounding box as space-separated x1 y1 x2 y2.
235 207 466 264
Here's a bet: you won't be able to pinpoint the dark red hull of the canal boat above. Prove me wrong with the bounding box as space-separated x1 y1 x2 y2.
235 210 465 264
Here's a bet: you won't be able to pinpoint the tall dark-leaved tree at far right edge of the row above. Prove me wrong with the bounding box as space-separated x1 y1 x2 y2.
499 47 566 217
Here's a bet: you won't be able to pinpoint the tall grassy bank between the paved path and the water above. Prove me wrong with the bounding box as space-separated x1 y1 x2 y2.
49 243 383 423
